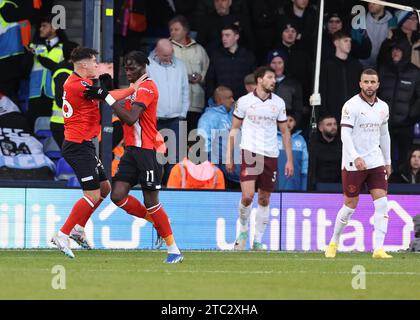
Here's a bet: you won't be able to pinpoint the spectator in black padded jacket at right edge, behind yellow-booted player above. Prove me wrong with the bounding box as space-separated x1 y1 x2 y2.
379 40 420 171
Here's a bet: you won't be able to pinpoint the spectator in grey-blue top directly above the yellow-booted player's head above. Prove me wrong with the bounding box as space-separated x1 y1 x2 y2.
360 3 397 69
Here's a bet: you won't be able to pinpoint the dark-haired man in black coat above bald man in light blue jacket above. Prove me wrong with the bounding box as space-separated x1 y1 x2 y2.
206 24 255 100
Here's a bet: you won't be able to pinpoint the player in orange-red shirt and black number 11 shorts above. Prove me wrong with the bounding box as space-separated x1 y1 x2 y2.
85 51 184 263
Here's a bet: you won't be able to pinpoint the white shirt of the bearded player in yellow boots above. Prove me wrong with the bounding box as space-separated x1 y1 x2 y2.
341 94 389 171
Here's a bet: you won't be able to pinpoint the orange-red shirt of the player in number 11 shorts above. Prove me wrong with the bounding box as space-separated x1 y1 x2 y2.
123 79 159 150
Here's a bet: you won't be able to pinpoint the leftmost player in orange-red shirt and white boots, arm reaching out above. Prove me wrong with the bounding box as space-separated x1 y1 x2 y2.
51 47 143 258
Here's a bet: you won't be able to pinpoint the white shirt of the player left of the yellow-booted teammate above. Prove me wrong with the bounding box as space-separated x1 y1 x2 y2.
233 91 287 158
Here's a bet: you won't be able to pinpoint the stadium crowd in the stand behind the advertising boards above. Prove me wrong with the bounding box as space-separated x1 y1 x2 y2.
0 0 420 191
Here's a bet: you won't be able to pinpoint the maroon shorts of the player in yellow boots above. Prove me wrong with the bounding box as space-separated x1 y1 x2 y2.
341 166 388 197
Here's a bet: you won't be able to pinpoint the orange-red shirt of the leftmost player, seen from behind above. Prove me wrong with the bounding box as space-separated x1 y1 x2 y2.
62 72 101 143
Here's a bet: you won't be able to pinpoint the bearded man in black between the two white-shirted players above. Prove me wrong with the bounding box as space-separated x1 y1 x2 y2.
310 115 342 189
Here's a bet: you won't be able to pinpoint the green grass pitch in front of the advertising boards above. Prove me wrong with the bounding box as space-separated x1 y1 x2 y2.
0 250 420 300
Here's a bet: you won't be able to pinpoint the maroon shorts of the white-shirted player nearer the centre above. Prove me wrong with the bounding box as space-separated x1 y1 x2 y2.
240 150 278 192
